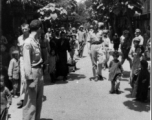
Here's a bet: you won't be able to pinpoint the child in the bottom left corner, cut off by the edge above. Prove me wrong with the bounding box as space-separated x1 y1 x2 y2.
0 74 12 120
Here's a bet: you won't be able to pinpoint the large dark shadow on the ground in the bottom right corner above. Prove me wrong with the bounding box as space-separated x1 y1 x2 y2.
123 100 150 112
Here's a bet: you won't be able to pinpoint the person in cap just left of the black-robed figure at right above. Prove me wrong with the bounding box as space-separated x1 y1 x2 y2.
129 37 144 87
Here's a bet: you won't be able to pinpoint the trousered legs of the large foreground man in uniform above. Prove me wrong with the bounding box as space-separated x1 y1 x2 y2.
23 68 43 120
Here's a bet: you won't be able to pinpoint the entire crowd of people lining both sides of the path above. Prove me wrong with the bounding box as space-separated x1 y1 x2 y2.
0 20 151 120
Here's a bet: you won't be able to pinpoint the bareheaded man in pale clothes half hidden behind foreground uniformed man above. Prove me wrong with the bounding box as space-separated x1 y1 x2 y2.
17 23 29 108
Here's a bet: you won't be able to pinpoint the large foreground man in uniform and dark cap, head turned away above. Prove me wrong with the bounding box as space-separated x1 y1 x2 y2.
23 20 43 120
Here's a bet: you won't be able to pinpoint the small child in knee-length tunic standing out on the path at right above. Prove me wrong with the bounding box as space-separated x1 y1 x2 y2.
109 51 123 94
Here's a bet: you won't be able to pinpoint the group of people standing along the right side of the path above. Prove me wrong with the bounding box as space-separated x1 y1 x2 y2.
87 22 151 102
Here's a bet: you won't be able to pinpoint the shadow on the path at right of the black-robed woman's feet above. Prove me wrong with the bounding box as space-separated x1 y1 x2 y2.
68 73 86 81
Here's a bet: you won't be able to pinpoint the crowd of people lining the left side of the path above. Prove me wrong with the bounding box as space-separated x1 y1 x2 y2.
0 20 89 120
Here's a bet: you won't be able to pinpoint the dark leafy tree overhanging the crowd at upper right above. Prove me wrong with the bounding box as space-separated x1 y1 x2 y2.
92 0 142 36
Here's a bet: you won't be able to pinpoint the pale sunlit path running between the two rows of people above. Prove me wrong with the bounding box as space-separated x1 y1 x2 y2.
9 47 150 120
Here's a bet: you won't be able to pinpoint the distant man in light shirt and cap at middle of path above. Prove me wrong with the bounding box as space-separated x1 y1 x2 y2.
78 25 86 58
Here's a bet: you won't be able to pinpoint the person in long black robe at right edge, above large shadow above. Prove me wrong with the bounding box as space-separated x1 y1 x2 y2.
132 61 150 101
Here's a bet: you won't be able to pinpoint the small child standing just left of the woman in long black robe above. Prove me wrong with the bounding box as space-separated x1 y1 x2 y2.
49 49 57 83
